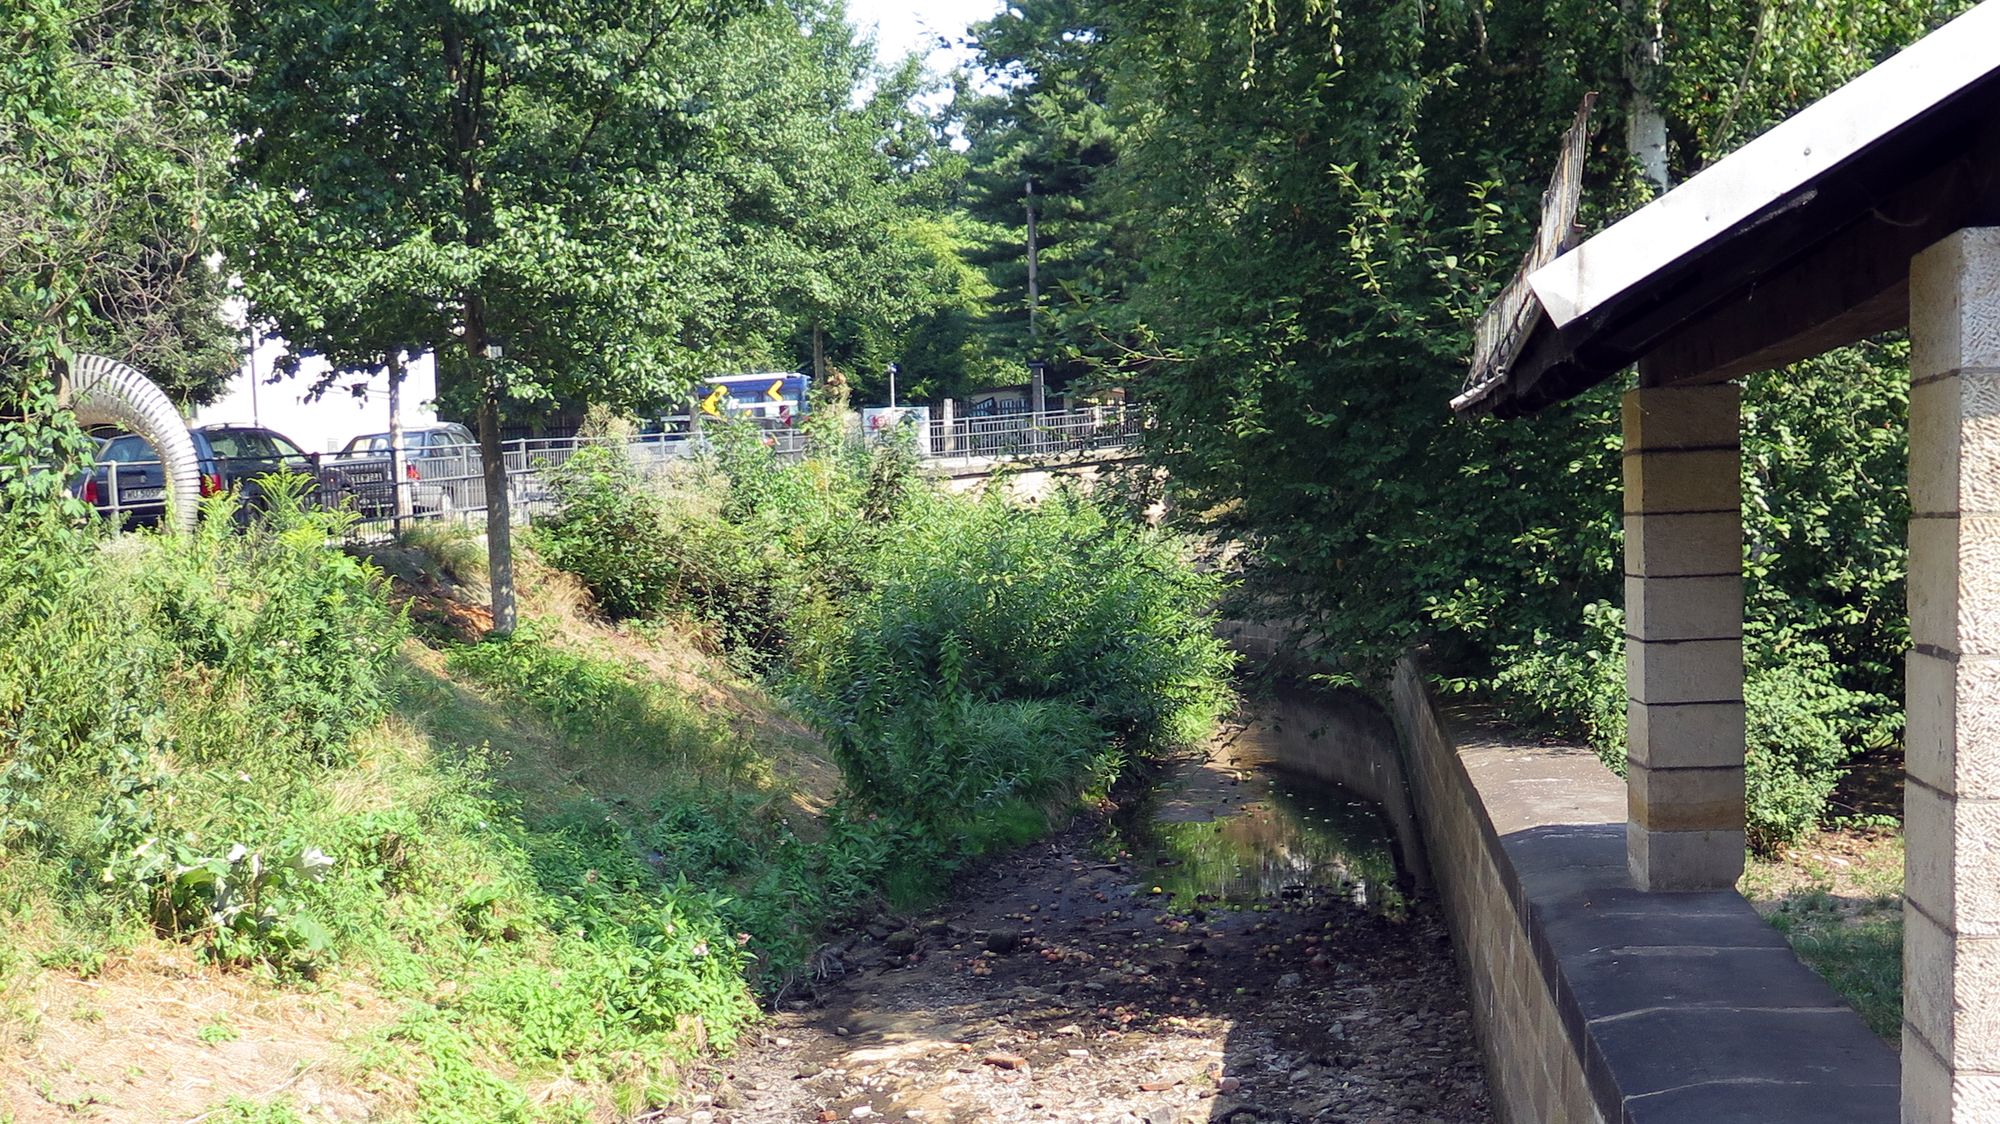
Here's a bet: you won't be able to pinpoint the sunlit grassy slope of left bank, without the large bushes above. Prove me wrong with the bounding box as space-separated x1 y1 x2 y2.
0 518 840 1122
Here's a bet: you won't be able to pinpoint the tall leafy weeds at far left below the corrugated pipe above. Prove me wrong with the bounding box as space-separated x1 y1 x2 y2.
0 480 400 968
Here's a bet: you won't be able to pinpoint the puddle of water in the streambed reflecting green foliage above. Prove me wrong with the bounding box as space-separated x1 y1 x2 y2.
1116 764 1408 916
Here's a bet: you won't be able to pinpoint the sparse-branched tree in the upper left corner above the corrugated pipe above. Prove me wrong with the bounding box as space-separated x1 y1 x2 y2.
0 0 238 416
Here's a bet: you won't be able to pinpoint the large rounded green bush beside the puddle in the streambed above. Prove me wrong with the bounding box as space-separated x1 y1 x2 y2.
794 494 1232 824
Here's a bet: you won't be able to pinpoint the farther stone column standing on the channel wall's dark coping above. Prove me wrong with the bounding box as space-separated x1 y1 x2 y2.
1624 384 1744 890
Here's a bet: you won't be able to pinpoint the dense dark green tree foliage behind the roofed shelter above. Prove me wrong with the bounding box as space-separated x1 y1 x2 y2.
944 0 1964 846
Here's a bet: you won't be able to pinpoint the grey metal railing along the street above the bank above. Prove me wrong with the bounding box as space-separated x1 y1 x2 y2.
76 406 1142 538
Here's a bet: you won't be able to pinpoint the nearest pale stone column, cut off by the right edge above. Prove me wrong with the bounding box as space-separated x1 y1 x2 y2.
1902 228 2000 1124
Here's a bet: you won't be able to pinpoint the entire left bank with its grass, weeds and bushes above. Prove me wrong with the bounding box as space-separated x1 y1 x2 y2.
0 426 1226 1122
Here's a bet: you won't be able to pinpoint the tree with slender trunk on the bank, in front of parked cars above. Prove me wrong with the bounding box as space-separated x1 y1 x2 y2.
232 0 772 632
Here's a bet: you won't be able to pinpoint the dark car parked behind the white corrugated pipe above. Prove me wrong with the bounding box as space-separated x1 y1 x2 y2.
76 426 358 526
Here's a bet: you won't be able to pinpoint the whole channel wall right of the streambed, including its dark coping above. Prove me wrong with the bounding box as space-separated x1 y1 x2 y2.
1392 660 1898 1124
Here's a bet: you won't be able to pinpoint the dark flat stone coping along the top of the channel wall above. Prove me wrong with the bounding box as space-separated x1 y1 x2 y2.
1448 716 1900 1124
